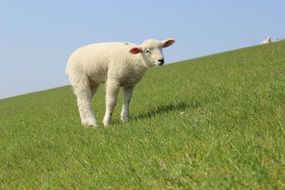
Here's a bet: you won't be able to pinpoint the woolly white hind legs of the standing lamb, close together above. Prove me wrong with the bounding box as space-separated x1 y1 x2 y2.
74 78 98 127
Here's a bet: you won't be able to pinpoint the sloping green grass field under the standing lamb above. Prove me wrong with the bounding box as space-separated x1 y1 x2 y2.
0 42 285 189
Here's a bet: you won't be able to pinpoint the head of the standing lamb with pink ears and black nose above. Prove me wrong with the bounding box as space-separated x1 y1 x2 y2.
129 38 175 67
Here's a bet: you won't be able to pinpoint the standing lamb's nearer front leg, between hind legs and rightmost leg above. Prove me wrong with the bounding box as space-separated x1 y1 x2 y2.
103 81 120 127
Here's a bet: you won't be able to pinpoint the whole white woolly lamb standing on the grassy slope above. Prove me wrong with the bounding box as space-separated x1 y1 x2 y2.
65 38 175 128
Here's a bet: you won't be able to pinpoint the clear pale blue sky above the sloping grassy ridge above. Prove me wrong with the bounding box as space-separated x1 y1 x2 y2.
0 0 285 99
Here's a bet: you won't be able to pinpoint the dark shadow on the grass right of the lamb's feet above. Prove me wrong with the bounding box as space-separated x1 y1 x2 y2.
131 101 200 120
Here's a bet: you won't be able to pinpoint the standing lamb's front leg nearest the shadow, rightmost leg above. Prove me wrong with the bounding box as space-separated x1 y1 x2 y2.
121 87 134 122
